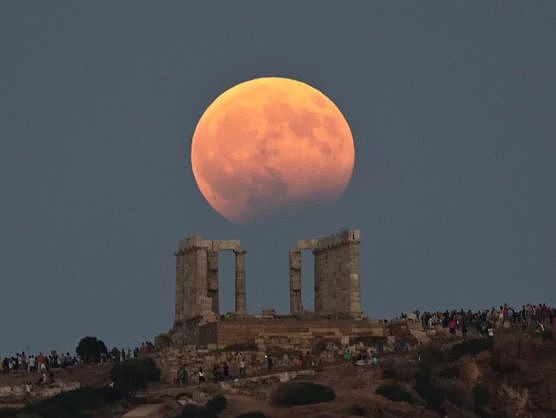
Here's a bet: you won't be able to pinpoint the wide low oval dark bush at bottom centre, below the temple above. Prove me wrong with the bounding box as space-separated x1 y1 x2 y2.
272 382 336 405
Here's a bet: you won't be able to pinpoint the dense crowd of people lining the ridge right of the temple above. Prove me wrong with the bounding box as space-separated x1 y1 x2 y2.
402 303 556 336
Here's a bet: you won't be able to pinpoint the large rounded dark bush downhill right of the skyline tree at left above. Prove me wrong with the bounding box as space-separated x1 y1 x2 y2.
110 357 160 397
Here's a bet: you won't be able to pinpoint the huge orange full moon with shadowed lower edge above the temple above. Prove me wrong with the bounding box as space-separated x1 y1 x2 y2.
191 77 355 223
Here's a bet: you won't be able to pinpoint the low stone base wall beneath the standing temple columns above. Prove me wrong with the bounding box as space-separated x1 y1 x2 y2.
156 318 386 381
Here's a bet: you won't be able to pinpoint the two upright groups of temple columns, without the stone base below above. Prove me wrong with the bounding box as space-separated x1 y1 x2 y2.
174 230 362 328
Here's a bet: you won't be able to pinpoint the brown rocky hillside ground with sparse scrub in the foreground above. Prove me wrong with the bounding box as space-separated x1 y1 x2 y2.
0 329 556 418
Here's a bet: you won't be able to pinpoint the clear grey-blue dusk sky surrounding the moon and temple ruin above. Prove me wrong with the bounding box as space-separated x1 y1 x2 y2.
0 1 556 355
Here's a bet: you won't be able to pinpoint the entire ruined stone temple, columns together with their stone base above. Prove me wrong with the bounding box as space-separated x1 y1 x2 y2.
157 230 391 380
